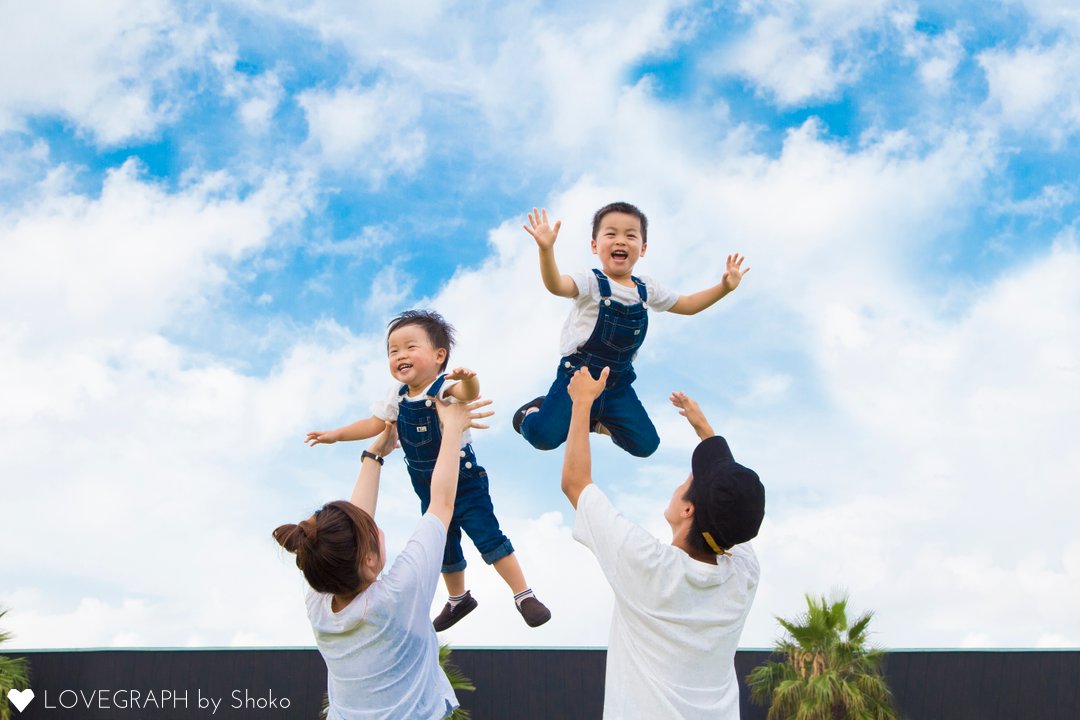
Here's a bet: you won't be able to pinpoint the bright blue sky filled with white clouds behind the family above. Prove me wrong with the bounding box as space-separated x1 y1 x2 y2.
0 0 1080 648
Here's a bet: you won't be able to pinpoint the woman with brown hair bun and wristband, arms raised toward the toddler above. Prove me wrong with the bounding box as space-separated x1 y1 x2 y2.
273 400 491 720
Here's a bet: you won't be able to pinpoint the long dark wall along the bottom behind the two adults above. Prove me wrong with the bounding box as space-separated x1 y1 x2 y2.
10 649 1080 720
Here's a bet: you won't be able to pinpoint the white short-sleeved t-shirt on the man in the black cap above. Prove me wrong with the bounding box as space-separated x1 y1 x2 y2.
573 485 759 720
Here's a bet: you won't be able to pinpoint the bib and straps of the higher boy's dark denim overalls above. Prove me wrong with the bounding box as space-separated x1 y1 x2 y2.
562 269 649 379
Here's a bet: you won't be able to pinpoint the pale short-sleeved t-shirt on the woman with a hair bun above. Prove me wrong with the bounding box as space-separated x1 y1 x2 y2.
307 513 458 720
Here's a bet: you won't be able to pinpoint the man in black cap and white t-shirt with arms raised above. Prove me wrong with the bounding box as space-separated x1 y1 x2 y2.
563 368 765 720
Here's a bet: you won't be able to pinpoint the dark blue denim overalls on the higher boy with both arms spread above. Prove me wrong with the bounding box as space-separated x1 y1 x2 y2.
522 269 660 458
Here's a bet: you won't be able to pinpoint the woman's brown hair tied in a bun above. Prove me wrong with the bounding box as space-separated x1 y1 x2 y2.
273 500 379 595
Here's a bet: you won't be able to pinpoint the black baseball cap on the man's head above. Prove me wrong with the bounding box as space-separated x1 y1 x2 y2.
689 435 765 549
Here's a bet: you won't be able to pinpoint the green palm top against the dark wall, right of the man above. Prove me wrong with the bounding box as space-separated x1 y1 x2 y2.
746 595 896 720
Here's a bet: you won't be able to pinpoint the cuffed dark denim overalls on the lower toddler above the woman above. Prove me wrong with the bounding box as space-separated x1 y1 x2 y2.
397 375 514 573
